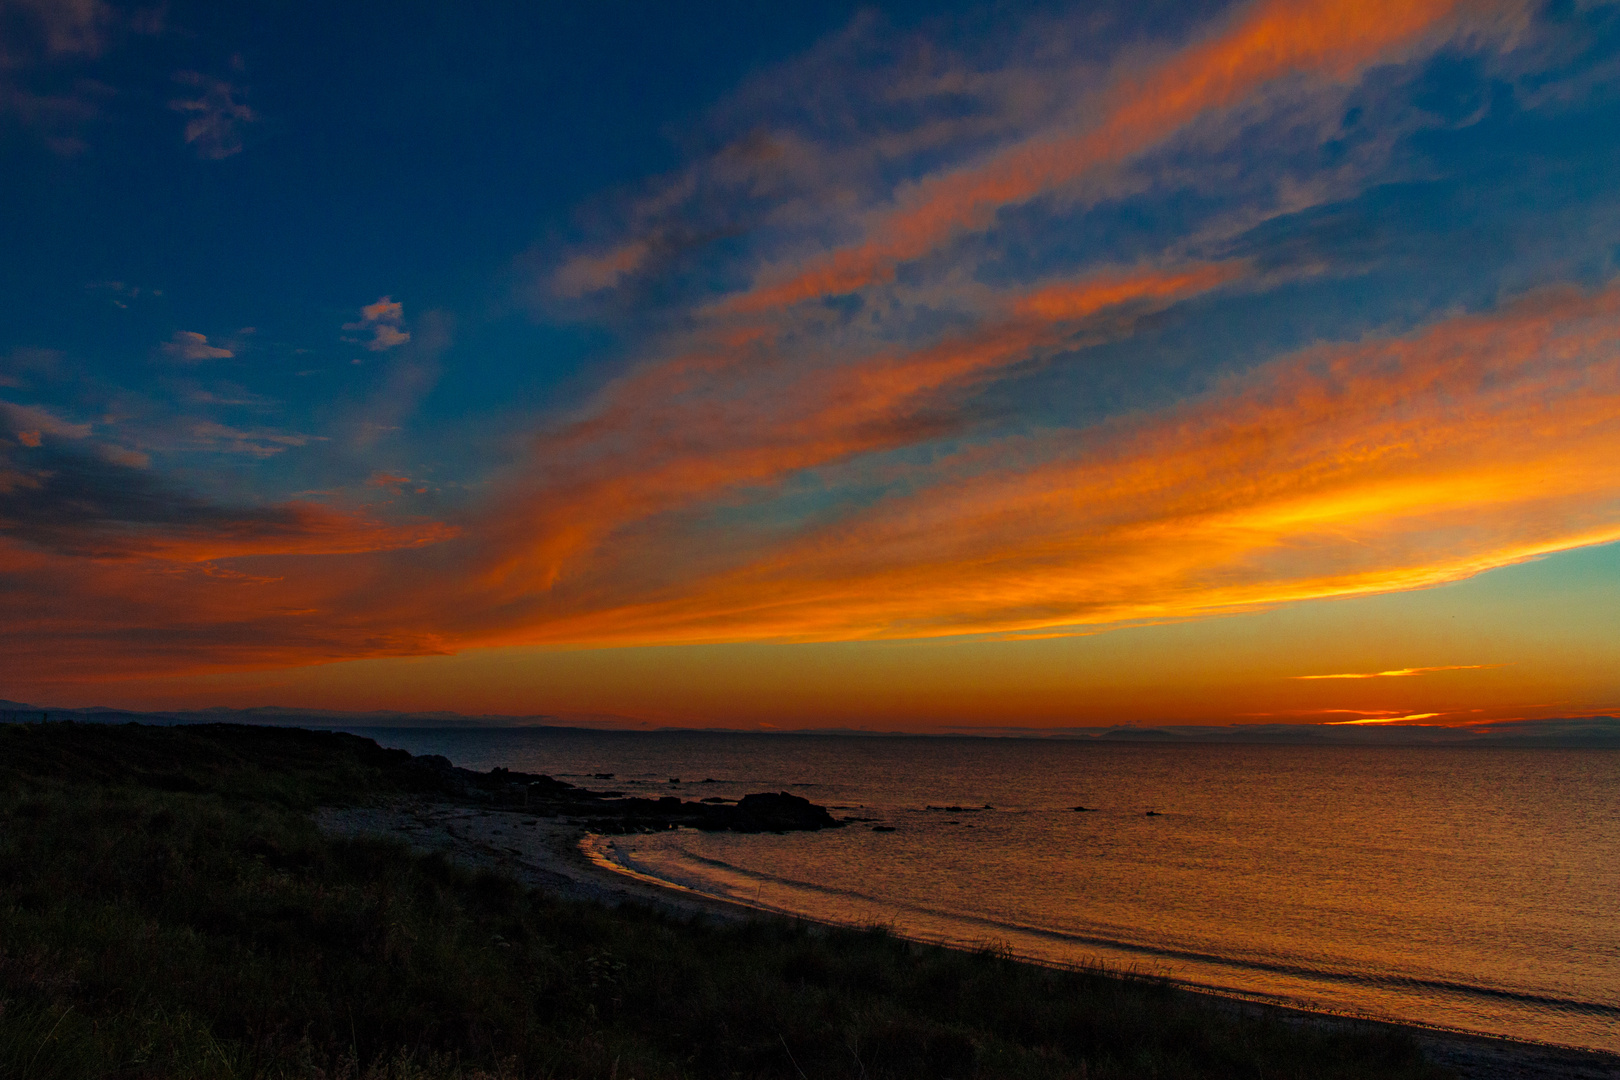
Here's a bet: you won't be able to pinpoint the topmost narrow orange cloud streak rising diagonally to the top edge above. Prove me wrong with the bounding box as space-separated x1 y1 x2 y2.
721 0 1513 314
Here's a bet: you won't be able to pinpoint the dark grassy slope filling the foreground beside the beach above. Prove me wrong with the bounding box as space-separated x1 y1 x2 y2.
0 724 1443 1080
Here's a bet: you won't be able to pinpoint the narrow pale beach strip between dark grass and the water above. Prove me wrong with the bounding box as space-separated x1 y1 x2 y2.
316 797 1620 1080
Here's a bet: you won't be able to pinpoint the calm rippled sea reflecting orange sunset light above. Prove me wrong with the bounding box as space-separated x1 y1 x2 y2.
354 730 1620 1051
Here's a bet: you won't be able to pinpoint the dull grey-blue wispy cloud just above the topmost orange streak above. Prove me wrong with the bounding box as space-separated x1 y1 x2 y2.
539 11 1092 311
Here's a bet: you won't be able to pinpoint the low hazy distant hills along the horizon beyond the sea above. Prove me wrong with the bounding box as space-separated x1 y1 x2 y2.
0 699 1620 748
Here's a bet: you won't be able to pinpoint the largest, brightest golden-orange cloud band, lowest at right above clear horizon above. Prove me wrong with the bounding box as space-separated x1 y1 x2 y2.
473 287 1620 643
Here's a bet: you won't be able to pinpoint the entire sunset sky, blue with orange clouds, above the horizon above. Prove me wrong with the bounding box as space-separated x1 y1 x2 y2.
0 0 1620 730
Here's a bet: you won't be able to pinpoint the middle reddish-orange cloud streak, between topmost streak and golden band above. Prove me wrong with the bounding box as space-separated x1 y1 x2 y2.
491 261 1247 591
